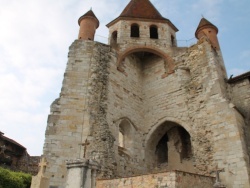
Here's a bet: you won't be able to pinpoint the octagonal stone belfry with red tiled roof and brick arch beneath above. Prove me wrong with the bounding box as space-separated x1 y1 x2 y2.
107 0 178 73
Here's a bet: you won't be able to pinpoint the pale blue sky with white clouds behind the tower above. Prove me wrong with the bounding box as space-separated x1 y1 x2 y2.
0 0 250 155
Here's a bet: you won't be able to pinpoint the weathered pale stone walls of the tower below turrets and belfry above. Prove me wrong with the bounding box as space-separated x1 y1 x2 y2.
44 36 249 188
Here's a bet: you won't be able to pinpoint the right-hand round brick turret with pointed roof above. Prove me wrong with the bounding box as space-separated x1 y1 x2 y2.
195 18 220 50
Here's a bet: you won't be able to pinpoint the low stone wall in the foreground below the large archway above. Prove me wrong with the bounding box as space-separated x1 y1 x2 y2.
96 171 214 188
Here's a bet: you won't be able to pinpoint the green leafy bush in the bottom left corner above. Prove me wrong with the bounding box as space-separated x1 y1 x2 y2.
0 167 31 188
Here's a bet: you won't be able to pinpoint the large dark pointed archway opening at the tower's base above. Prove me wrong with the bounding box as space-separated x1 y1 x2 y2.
145 121 194 172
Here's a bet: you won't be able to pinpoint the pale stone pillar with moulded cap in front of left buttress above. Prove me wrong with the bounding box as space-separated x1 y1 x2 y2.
65 159 99 188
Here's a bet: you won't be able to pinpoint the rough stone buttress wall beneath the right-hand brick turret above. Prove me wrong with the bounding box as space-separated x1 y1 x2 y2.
170 41 249 187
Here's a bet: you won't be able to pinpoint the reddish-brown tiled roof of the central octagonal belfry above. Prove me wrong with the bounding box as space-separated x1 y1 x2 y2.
107 0 178 31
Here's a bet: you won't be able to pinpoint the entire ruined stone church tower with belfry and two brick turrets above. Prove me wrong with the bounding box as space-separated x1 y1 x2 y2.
44 0 250 188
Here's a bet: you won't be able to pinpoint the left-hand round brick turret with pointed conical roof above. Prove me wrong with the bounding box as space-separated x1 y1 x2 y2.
78 10 99 40
